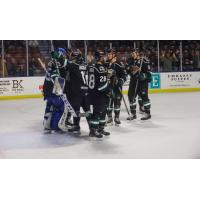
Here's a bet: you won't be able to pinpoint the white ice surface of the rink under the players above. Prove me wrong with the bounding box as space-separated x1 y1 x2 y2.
0 92 200 158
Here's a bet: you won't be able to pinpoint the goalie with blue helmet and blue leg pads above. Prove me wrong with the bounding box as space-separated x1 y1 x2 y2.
43 48 67 131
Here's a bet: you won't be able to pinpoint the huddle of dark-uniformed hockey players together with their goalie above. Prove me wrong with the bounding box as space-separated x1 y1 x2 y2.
43 48 151 138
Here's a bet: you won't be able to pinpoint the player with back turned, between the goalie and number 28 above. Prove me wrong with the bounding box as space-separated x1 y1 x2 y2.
66 49 91 134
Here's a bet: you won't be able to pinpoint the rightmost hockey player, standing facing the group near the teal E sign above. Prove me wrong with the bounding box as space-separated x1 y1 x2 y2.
127 49 151 120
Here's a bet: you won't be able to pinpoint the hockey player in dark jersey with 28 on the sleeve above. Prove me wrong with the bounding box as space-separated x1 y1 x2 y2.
88 51 110 138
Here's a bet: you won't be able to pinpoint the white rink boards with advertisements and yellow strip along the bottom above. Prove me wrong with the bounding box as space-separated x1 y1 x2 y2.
0 72 200 100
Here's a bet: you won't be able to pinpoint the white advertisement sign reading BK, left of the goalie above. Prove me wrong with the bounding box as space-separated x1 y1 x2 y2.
0 77 44 97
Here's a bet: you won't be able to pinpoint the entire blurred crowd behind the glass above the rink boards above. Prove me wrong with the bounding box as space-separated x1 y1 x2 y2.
0 40 200 77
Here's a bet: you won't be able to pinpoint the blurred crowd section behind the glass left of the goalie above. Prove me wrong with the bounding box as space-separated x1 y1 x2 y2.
0 40 48 77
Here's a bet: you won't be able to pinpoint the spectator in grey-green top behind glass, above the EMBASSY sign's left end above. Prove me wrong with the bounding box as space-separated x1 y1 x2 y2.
160 51 178 72
